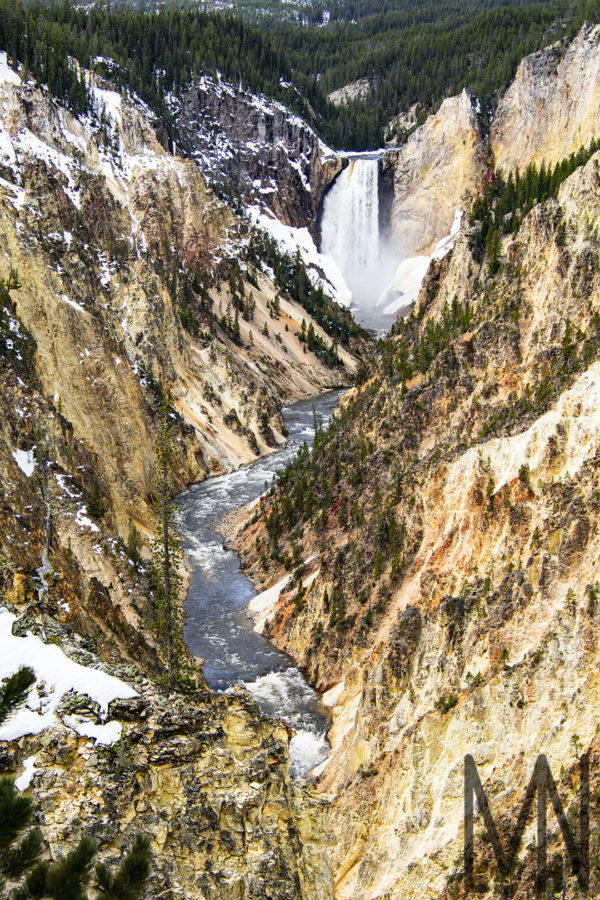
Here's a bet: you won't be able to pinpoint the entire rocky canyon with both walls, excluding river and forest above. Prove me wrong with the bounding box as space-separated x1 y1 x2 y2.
0 17 600 900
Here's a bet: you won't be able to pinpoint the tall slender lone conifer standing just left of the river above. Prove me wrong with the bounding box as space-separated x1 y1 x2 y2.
150 387 187 688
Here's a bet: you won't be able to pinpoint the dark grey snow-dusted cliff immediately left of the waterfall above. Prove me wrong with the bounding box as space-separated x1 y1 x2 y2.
173 78 344 240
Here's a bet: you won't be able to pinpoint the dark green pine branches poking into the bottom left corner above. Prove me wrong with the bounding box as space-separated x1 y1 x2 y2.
0 666 152 900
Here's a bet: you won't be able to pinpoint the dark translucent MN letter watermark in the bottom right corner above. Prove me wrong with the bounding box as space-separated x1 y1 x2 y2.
464 754 590 897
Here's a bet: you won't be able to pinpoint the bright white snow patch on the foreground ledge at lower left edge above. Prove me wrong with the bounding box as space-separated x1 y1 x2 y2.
0 609 137 743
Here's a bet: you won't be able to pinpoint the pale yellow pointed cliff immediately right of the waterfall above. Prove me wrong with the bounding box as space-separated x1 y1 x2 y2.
381 91 487 259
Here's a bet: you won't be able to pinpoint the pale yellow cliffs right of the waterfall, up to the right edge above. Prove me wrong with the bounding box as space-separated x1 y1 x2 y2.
382 25 600 268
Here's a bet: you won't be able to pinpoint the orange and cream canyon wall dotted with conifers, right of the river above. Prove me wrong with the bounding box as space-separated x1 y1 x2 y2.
233 146 600 900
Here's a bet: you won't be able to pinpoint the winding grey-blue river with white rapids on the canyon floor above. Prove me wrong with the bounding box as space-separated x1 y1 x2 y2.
179 391 343 776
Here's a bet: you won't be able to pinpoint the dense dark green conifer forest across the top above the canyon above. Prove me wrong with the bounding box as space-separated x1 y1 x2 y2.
0 0 600 150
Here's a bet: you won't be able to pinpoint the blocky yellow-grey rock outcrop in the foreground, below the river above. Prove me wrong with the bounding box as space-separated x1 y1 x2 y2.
0 612 333 900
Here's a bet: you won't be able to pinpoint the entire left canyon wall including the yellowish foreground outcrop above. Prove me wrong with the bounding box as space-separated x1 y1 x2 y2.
0 58 357 900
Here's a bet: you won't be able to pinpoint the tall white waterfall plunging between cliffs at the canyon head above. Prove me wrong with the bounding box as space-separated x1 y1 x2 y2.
321 156 390 324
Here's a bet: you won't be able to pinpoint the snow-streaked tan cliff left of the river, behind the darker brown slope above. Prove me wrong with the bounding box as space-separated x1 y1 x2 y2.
0 63 353 534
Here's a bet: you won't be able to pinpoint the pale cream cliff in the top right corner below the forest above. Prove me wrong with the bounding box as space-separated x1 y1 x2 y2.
490 25 600 173
